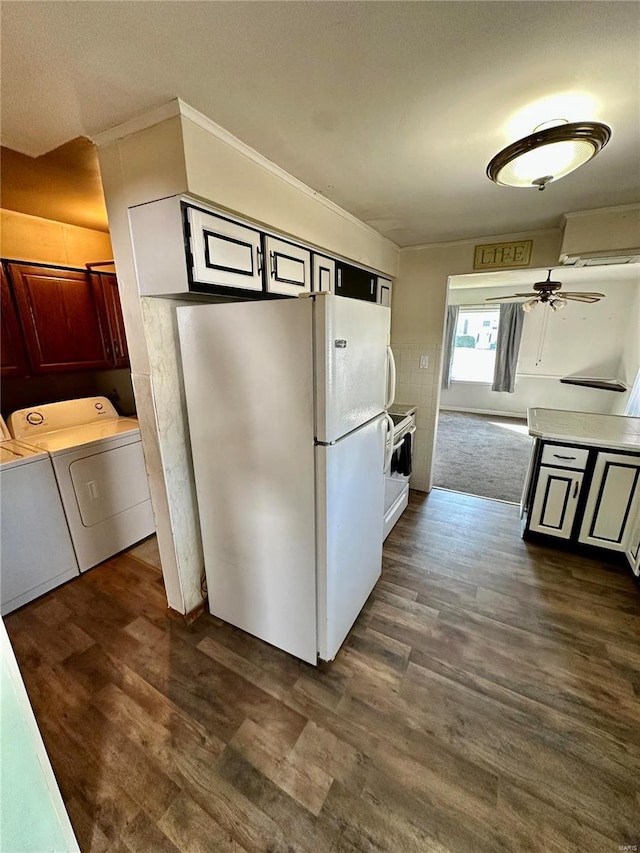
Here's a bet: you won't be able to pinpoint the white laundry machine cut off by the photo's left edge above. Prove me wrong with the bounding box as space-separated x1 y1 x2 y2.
0 418 79 616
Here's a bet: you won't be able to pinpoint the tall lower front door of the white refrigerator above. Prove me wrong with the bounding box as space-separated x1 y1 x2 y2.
316 416 385 660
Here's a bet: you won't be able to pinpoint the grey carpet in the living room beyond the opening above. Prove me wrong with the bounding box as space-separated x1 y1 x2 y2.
433 412 533 503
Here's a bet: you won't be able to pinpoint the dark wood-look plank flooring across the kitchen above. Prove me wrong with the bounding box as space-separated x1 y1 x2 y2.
6 490 640 853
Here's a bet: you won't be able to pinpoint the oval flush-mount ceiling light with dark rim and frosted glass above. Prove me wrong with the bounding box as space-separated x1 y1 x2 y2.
487 122 611 190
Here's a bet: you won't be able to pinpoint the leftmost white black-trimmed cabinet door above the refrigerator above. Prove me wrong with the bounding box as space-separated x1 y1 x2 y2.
187 207 262 290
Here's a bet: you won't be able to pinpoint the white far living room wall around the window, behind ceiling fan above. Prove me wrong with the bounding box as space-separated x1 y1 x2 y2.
440 276 640 415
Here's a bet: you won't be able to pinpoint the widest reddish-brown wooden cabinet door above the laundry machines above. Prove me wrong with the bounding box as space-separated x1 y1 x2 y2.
9 264 110 373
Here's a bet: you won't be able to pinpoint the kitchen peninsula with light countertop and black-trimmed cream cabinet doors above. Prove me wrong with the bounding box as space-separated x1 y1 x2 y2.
521 408 640 575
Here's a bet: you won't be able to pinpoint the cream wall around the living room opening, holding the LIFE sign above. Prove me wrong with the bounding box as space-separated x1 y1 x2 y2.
391 229 560 491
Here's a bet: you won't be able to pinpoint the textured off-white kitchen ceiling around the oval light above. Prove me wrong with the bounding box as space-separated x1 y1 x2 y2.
1 0 640 246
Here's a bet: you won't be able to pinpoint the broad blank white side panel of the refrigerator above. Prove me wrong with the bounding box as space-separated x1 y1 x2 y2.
177 299 318 664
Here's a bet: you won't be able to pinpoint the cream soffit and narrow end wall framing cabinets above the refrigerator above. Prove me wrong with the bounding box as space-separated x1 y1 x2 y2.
96 101 398 613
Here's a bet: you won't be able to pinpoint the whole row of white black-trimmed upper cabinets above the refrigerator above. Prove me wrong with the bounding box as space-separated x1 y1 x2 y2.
129 196 391 305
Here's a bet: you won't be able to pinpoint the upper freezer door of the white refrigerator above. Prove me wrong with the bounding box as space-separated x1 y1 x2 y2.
314 295 391 443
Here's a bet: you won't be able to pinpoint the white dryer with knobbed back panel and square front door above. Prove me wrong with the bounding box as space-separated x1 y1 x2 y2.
9 397 155 572
